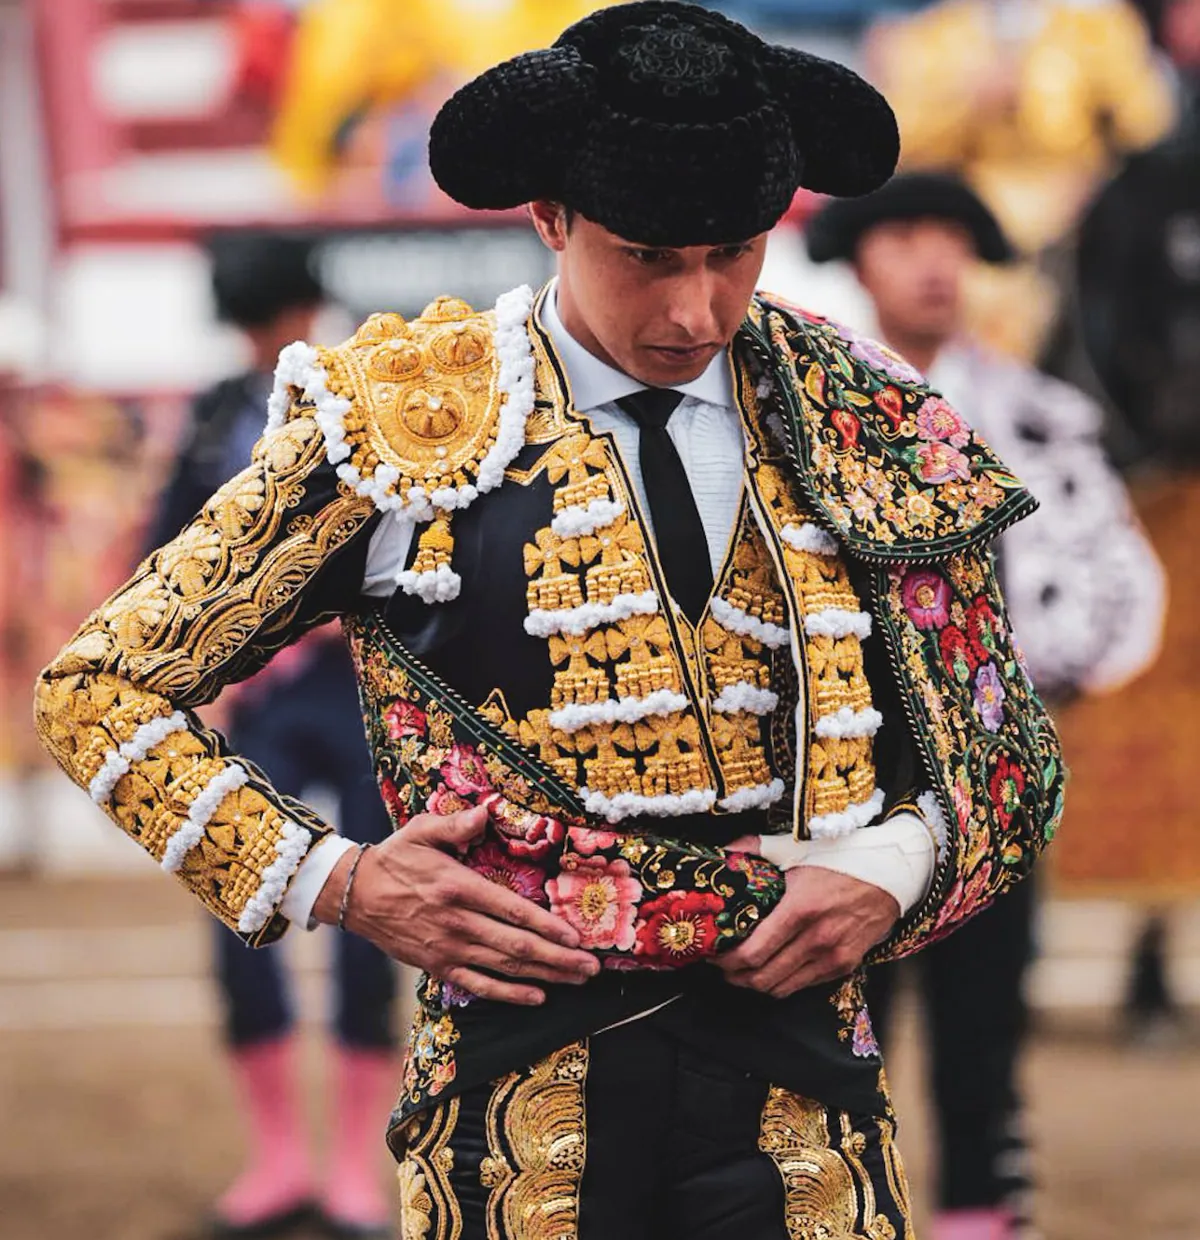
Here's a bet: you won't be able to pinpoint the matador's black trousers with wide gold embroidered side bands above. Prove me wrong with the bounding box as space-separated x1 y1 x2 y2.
399 1017 911 1240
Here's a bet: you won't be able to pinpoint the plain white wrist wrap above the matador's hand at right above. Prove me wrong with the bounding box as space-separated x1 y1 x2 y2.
759 813 937 916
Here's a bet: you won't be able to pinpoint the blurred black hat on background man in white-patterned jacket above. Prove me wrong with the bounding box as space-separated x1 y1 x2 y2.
805 172 1013 263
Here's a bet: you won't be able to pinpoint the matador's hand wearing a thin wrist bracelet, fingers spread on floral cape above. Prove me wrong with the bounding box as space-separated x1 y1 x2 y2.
312 808 600 1004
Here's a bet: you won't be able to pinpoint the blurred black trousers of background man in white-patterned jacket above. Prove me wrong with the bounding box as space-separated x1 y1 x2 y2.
867 879 1036 1213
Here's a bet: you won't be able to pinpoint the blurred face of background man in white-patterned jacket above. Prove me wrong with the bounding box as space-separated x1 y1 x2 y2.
854 219 974 343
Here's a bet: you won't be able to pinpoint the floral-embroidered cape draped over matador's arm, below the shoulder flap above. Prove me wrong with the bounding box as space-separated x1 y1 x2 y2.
874 548 1066 961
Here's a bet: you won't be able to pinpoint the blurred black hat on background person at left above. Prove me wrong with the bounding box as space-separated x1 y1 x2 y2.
207 231 325 327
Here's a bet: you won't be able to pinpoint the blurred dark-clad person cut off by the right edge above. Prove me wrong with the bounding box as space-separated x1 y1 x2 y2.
1077 0 1200 1042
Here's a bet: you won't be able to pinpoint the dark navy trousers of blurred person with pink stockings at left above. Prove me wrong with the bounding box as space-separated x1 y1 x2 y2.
213 647 397 1050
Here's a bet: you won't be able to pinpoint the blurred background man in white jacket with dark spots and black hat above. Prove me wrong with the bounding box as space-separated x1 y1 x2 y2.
807 174 1165 1240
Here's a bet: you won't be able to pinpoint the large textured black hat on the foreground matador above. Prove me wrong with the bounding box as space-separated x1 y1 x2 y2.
429 0 900 247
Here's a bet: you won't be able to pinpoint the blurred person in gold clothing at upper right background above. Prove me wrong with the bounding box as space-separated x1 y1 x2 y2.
868 0 1173 361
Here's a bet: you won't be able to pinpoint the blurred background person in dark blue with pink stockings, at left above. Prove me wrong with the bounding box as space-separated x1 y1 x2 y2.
148 233 398 1238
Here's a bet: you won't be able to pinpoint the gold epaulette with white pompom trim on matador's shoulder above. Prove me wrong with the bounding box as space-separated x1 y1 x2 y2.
268 286 534 603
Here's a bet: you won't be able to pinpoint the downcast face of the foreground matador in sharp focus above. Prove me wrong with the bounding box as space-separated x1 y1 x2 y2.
532 202 766 387
